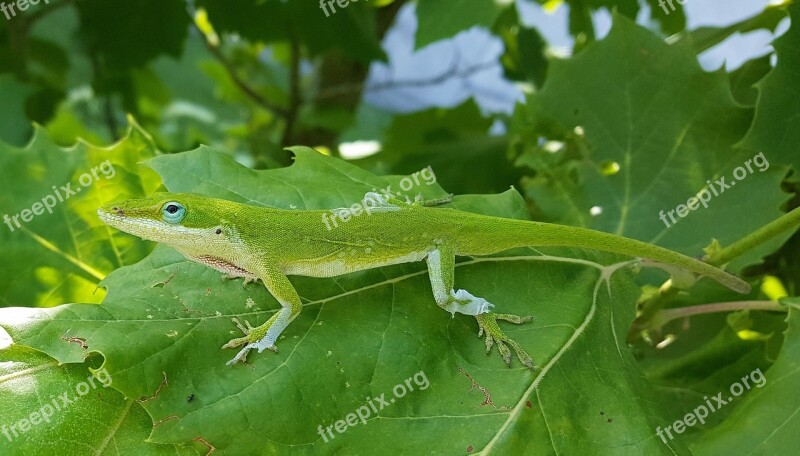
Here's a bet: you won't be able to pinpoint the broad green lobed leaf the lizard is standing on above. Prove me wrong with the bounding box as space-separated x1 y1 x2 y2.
0 148 686 455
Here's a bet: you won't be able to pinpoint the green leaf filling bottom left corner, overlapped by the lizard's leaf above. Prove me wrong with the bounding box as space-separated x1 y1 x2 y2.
0 348 199 456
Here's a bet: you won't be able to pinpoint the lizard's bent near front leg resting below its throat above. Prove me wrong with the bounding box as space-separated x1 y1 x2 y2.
222 264 303 366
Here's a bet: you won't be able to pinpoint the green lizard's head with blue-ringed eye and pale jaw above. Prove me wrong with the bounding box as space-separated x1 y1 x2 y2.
97 193 241 253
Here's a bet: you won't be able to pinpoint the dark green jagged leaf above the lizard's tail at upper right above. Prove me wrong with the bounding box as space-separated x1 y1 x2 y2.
518 15 790 270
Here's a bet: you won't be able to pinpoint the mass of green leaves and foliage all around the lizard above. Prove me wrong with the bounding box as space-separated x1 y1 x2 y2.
0 0 800 455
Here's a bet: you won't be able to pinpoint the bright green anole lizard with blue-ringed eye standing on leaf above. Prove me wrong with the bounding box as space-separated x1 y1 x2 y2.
97 193 750 368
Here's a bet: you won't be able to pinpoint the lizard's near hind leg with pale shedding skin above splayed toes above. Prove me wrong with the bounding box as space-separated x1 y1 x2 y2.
425 244 533 368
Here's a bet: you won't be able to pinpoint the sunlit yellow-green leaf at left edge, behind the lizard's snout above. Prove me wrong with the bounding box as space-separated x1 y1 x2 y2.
0 125 161 307
